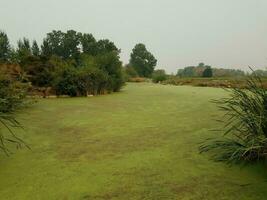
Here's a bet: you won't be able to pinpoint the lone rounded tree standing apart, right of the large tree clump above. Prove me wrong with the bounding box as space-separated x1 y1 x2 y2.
130 44 157 77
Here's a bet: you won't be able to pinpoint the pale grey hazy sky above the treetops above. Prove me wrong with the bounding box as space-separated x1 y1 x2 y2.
0 0 267 72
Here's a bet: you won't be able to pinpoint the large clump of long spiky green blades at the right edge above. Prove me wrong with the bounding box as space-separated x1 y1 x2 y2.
200 72 267 163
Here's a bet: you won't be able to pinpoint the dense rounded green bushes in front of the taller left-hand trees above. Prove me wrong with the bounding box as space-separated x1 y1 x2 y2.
53 52 124 96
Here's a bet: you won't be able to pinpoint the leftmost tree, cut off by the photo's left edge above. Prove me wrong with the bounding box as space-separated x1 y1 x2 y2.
0 31 11 62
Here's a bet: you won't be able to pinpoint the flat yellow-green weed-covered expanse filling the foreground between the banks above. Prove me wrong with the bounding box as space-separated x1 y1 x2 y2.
0 83 267 200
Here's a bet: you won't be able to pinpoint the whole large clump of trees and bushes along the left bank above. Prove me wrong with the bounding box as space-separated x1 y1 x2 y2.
0 30 124 96
